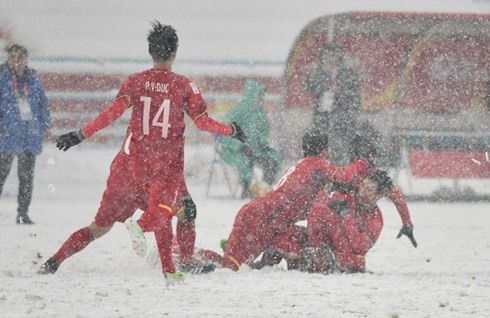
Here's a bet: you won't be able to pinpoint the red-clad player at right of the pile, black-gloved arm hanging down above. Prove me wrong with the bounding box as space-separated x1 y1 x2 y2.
308 170 417 273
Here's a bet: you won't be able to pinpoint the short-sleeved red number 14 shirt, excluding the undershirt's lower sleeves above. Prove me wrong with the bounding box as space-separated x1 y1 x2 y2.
117 68 207 153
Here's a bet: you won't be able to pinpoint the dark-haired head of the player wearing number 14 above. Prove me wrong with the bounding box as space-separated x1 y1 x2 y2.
147 20 179 61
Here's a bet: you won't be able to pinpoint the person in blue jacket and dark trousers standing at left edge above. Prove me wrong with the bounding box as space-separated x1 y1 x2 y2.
0 44 51 224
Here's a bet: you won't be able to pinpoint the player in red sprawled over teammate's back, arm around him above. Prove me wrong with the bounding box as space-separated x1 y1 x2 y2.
222 132 371 271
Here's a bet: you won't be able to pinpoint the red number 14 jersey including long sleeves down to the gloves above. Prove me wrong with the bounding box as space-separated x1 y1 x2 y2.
83 67 232 148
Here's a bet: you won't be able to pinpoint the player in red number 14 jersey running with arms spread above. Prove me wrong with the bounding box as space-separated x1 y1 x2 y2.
49 21 246 281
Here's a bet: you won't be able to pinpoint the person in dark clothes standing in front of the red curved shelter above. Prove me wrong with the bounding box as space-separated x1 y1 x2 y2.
304 43 361 165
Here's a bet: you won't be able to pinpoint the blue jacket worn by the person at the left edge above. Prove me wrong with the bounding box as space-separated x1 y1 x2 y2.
0 64 51 154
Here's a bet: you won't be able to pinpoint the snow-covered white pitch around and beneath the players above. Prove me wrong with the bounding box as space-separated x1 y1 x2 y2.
0 144 490 318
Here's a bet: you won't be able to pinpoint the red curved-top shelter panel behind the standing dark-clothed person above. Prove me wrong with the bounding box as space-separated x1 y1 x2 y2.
285 13 490 111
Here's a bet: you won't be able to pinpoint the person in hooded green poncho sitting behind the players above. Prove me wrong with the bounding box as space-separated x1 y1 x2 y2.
220 80 282 198
